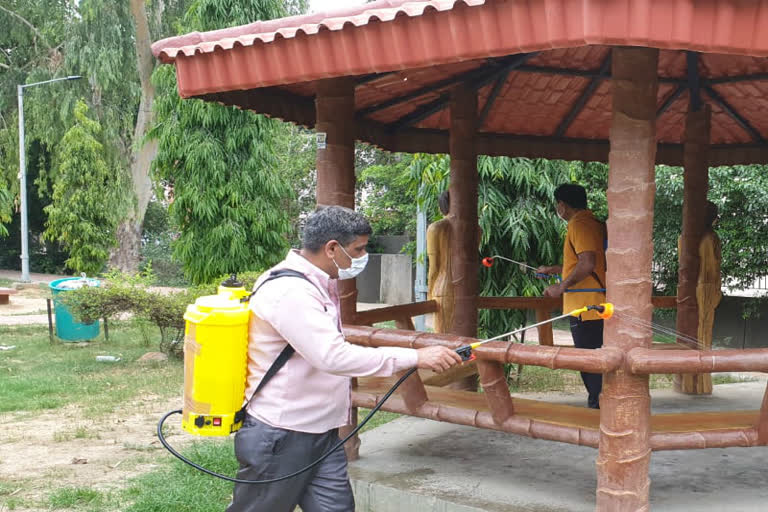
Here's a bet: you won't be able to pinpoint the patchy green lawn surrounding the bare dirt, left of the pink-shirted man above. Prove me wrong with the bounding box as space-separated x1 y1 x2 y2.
0 322 414 512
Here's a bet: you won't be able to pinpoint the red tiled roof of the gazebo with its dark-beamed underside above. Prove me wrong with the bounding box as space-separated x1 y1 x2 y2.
153 0 768 165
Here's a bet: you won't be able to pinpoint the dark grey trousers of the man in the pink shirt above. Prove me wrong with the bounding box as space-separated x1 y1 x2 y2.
227 415 355 512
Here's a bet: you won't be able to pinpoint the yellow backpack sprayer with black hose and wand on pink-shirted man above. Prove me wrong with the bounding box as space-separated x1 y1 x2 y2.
157 272 613 484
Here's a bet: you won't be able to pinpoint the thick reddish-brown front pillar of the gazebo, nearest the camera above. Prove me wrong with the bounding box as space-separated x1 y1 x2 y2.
597 48 659 512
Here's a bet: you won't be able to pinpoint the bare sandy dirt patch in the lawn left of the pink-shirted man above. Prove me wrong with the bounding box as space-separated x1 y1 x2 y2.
0 395 191 512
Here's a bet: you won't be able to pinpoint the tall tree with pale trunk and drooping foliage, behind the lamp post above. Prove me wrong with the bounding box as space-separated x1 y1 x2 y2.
0 0 193 269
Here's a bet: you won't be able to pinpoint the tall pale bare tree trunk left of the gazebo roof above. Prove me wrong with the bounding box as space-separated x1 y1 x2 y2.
109 0 157 272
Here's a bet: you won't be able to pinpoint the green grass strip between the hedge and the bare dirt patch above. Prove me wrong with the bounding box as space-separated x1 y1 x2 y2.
0 323 183 417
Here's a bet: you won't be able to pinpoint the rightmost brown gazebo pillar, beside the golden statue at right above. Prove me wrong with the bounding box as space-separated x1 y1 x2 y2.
675 105 712 394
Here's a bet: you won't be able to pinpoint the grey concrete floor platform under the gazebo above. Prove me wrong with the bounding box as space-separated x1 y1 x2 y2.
350 381 768 512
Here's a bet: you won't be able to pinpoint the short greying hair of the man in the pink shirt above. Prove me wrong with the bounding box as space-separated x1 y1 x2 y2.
302 206 373 252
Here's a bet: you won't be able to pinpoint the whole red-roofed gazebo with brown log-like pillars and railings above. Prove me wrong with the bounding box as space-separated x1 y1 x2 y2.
153 0 768 512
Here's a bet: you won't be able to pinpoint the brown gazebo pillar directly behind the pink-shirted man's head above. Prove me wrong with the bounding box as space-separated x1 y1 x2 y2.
315 78 360 460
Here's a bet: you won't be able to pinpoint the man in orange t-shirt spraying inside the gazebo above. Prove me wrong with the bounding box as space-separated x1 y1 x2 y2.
537 184 606 409
